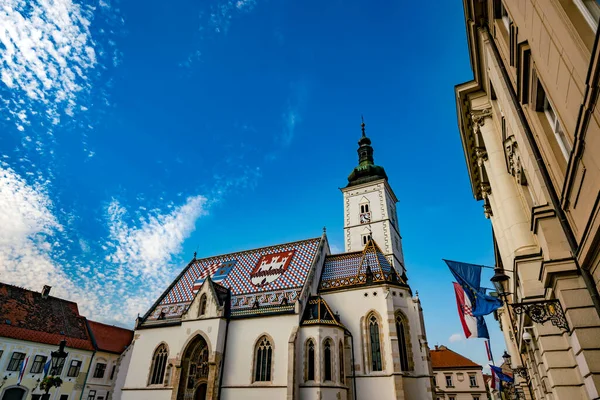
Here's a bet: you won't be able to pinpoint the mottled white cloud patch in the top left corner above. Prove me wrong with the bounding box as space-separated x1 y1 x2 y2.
0 0 97 130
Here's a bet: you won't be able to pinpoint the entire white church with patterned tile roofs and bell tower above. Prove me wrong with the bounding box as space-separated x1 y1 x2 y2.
121 124 433 400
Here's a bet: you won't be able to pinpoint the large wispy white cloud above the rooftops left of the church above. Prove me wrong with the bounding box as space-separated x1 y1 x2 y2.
0 167 211 326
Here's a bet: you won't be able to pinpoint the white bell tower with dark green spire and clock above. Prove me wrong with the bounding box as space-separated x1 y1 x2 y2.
341 120 406 275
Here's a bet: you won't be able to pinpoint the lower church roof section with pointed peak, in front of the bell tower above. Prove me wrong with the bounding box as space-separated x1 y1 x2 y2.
320 239 405 290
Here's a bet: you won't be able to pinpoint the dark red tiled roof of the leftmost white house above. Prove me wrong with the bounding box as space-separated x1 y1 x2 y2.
0 283 94 350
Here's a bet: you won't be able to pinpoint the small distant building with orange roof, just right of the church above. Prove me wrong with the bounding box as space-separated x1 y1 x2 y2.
431 346 487 400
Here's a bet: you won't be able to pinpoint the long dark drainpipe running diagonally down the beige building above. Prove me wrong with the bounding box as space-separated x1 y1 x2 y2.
484 26 600 315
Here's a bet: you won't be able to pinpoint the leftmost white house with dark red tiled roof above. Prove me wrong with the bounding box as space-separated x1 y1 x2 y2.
0 283 94 400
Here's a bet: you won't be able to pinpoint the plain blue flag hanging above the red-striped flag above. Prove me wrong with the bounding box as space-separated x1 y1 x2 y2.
444 260 502 317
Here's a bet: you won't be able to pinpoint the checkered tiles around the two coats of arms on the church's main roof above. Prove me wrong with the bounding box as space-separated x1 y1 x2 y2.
159 238 321 306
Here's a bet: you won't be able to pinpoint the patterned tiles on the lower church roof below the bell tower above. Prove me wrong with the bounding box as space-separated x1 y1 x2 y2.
321 240 393 288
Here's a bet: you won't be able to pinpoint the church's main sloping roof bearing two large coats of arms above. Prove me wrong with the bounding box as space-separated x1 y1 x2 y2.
144 237 324 320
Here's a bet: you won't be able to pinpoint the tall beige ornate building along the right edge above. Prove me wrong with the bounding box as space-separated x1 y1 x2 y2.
455 0 600 399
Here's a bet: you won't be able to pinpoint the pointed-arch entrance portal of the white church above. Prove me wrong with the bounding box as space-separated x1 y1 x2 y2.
177 335 208 400
